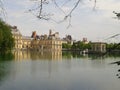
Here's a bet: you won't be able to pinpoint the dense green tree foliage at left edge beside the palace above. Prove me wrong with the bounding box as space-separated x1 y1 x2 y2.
0 20 14 52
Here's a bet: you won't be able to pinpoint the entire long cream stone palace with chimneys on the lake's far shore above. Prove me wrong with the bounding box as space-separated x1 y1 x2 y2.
11 26 62 51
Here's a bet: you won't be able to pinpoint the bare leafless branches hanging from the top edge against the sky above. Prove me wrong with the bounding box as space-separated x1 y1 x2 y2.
29 0 97 28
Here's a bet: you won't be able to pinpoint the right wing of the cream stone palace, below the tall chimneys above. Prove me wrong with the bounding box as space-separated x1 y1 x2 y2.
31 30 62 51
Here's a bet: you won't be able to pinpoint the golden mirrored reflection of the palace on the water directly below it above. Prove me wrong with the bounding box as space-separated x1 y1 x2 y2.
13 50 62 61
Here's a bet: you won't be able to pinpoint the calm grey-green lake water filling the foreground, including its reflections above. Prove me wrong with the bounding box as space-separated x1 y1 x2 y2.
0 51 120 90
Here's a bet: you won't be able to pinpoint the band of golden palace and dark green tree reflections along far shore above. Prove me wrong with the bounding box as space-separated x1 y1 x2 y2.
12 50 120 61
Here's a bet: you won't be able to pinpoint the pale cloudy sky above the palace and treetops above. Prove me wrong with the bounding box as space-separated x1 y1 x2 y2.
3 0 120 41
